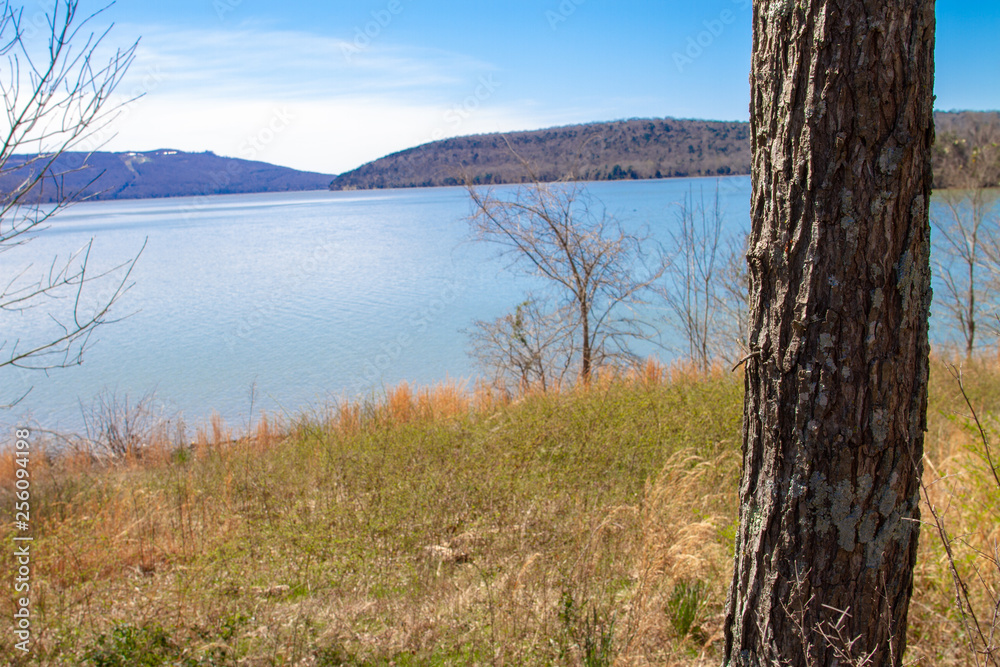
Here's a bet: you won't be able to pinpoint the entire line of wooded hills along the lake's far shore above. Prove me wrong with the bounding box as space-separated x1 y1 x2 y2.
0 111 1000 203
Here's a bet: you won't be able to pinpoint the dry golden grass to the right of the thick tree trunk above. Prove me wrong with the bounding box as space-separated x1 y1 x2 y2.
909 359 1000 667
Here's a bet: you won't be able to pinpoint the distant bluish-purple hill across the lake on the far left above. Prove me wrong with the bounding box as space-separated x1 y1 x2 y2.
0 150 333 203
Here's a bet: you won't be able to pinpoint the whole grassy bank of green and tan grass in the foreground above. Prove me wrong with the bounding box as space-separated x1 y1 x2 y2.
0 364 1000 666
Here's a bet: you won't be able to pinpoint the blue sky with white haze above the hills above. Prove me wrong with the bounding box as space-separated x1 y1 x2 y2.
7 0 1000 174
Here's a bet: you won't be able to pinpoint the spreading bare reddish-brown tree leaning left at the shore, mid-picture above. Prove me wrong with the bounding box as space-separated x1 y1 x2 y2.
468 181 665 382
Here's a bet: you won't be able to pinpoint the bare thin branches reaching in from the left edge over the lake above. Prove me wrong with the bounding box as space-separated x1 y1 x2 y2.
0 0 141 404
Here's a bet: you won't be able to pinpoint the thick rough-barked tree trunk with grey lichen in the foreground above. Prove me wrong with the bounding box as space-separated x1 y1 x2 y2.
725 0 934 667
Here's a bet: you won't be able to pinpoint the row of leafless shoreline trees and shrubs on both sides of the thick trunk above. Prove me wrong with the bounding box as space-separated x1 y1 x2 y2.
467 114 1000 390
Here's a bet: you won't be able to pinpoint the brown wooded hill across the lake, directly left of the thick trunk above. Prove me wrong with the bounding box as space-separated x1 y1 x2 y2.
330 119 750 190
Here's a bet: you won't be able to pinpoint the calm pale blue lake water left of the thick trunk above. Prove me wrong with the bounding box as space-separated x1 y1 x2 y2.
0 177 750 430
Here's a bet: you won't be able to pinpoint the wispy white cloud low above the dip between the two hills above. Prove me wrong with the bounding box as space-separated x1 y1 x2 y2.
90 28 560 173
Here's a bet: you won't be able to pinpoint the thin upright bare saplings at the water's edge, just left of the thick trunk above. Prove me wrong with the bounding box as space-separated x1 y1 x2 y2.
659 182 746 370
